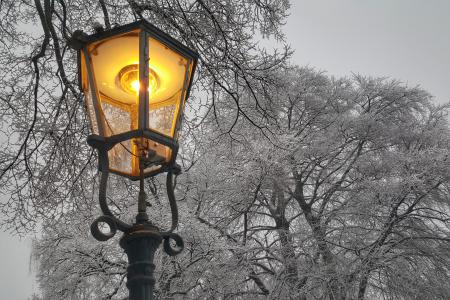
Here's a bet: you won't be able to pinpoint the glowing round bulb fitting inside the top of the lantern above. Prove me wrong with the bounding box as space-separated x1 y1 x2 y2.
118 64 159 95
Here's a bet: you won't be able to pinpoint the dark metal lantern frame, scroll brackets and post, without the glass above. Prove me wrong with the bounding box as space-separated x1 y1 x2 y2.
69 20 198 300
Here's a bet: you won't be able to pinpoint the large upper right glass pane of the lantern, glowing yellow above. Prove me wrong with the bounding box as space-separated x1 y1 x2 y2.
148 37 192 138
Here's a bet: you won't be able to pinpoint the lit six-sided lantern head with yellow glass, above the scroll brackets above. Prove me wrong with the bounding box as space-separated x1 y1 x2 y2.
78 21 198 180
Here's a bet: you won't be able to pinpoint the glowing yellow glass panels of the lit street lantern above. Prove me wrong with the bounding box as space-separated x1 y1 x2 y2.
81 27 193 176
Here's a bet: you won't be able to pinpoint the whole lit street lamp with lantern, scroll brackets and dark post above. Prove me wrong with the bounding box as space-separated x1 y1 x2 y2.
70 20 198 300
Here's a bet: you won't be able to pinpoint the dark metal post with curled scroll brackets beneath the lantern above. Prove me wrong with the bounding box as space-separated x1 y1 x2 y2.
88 133 184 300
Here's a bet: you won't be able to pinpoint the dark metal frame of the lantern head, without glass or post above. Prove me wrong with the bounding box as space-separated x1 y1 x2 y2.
72 20 198 180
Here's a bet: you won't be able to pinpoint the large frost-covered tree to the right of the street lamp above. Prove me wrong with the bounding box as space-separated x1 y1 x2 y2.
183 68 450 299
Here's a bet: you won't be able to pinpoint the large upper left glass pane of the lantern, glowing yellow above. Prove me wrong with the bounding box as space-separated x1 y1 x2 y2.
88 31 139 136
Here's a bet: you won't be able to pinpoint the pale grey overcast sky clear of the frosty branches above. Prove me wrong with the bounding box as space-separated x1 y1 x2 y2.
0 0 450 300
